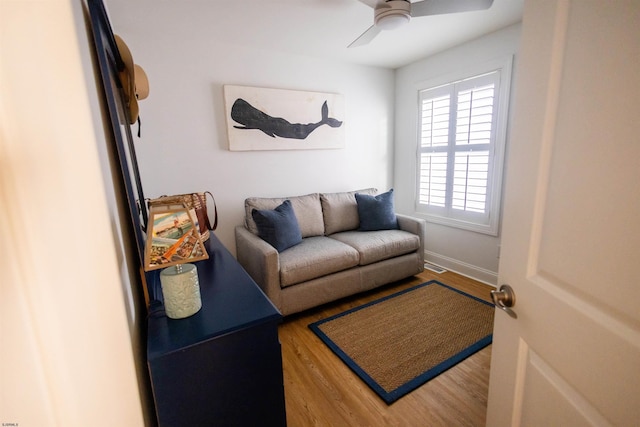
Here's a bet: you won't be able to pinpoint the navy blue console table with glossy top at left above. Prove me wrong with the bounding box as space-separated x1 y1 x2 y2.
147 233 286 427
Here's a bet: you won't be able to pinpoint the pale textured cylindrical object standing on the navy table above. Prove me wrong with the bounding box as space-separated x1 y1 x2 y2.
160 264 202 319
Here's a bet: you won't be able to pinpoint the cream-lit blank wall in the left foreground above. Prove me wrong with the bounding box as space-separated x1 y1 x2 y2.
0 0 144 426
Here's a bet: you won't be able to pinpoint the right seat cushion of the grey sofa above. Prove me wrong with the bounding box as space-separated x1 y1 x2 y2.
330 230 420 265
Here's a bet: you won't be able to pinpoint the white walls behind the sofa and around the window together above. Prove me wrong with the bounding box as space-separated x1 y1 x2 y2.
107 0 520 283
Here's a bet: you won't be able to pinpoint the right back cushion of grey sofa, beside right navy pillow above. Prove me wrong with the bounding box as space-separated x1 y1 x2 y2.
320 188 378 235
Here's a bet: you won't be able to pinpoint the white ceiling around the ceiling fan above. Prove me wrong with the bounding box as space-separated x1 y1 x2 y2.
105 0 523 68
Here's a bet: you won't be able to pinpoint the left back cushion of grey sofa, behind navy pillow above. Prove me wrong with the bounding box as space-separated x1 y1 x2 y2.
244 193 324 237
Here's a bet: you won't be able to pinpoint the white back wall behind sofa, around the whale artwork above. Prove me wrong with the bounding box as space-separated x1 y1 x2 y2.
107 0 394 253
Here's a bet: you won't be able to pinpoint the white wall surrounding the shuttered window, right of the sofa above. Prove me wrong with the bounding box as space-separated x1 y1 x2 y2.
394 24 520 285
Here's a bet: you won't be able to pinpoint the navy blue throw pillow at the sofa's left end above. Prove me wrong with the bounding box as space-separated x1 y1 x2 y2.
251 200 302 252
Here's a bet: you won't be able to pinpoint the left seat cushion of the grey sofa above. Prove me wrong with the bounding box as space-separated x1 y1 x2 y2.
280 236 358 288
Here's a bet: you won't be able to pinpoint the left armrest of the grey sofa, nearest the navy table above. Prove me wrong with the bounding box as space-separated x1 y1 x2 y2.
235 226 281 309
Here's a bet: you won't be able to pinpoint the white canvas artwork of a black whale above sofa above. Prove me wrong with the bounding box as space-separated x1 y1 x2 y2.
224 85 345 151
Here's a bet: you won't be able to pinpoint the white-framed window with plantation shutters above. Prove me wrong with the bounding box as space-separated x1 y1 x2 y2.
416 58 511 235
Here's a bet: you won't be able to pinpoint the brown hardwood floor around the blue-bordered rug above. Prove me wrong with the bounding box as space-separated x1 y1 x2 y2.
279 270 493 427
